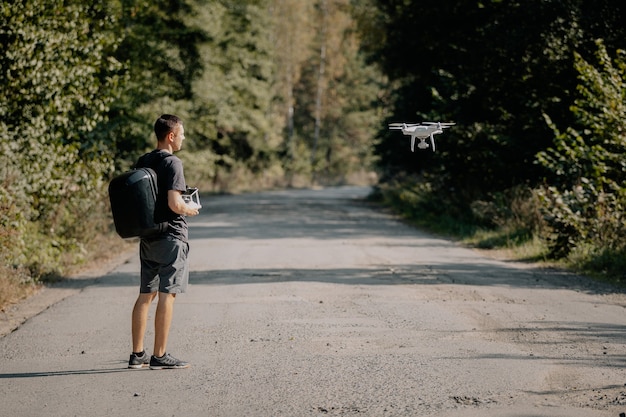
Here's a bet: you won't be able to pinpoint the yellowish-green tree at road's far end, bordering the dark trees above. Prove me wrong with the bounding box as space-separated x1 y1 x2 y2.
294 0 384 179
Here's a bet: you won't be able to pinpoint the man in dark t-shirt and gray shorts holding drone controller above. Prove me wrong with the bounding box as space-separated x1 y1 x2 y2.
128 114 198 369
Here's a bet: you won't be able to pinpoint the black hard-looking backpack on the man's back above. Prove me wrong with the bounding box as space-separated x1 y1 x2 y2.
109 153 168 239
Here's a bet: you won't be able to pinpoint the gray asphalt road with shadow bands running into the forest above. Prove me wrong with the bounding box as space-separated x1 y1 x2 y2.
0 187 626 417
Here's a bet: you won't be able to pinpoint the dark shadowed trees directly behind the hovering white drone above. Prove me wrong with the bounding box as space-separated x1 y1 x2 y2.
365 0 625 198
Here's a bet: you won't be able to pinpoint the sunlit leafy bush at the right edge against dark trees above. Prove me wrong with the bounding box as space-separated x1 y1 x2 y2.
537 42 626 257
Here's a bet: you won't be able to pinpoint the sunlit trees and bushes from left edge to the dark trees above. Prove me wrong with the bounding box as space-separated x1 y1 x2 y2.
0 0 382 308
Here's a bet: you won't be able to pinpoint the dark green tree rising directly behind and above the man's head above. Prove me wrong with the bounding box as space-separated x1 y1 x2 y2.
101 0 209 161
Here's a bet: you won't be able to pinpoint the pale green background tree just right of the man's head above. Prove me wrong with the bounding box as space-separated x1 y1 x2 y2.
186 0 281 178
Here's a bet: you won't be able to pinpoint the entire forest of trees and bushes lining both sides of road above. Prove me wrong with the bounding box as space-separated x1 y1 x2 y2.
0 0 626 306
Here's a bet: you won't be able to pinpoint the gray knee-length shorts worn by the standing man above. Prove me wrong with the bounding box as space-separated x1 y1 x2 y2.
139 237 189 294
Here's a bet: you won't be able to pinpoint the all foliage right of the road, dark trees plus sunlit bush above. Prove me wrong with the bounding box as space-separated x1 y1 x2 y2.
359 0 626 282
